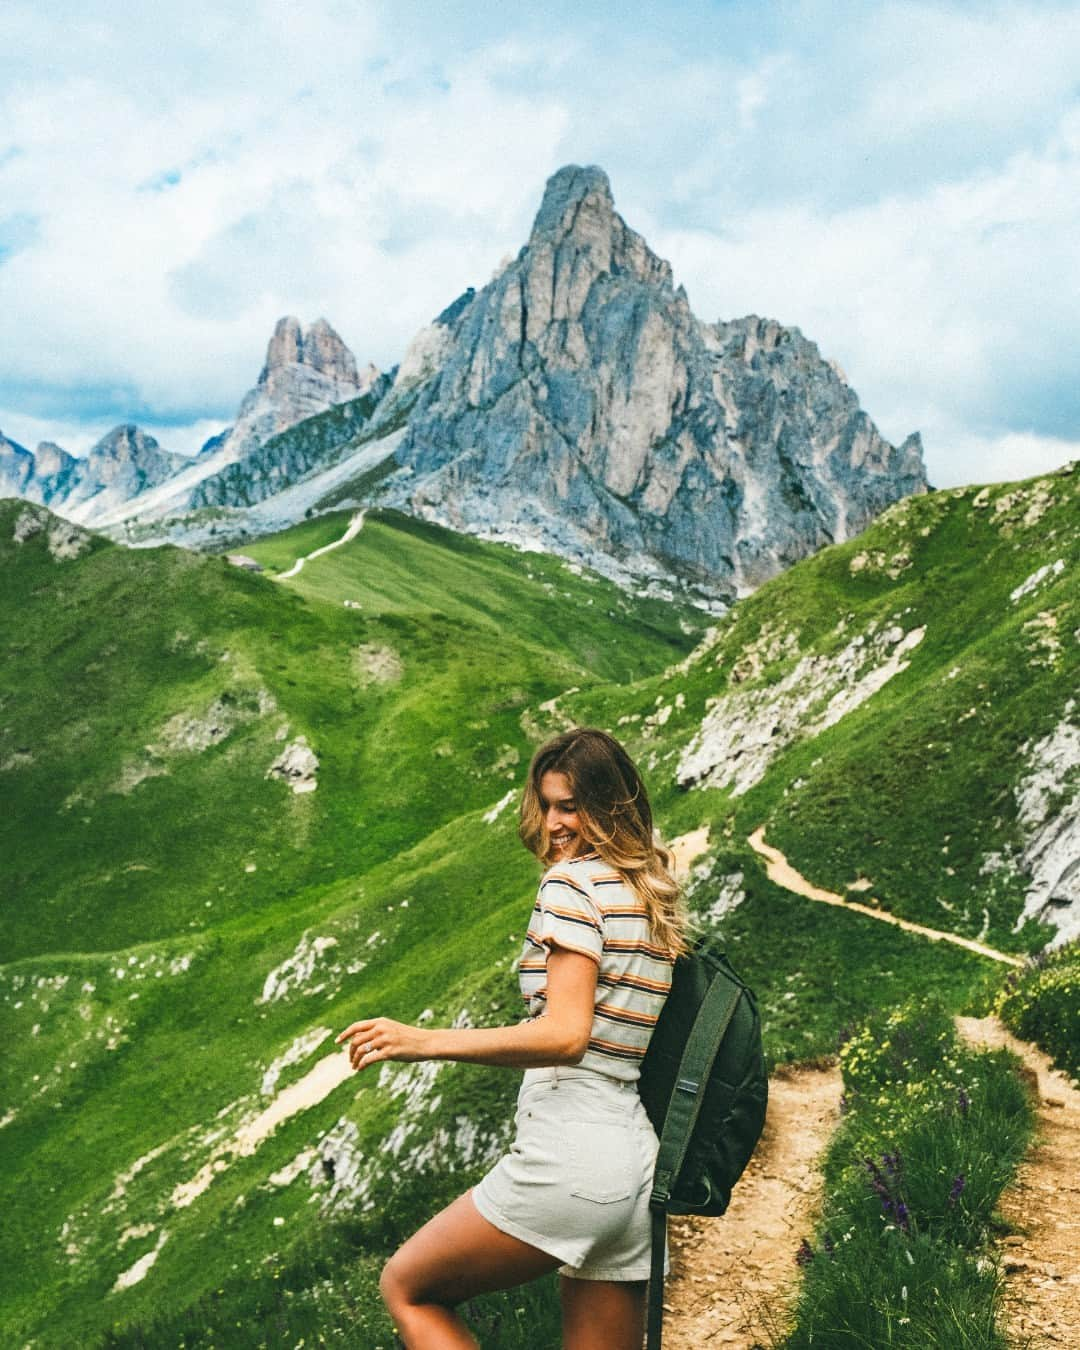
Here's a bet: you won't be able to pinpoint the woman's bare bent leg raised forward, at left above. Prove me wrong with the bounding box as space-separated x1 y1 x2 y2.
379 1191 564 1350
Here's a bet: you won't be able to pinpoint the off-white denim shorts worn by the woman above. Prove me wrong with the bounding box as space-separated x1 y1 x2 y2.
471 1065 671 1280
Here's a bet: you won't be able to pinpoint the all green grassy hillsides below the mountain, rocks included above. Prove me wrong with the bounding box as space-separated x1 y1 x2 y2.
0 468 1080 1350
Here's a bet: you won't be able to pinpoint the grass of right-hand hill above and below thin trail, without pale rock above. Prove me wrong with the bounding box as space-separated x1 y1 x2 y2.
526 466 1080 1060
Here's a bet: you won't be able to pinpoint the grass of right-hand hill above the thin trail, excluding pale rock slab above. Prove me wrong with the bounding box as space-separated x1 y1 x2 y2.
563 468 1080 950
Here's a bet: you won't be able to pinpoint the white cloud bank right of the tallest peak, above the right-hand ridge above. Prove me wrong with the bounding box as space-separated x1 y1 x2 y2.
653 99 1080 483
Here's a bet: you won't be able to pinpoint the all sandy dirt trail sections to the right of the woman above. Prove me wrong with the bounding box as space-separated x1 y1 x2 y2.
663 826 1080 1350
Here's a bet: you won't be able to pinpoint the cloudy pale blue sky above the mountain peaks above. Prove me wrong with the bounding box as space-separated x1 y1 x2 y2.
0 0 1080 487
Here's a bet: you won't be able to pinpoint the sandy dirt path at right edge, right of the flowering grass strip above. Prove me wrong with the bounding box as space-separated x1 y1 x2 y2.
956 1017 1080 1350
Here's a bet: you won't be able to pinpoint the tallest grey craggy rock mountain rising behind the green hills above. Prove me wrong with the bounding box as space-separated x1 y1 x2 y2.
372 166 927 595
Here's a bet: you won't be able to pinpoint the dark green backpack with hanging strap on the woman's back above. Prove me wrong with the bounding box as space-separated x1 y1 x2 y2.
637 934 768 1350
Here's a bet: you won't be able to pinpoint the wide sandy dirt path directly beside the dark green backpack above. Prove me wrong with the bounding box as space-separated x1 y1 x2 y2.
664 1065 844 1350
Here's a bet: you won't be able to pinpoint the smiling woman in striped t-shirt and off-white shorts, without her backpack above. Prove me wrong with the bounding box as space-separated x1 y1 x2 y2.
338 726 687 1350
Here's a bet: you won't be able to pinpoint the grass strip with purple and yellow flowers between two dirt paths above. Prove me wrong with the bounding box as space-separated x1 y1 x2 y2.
782 998 1034 1350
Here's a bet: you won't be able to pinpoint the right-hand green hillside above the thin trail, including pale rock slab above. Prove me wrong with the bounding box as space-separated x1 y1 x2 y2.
559 464 1080 952
